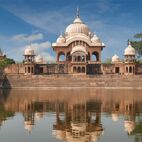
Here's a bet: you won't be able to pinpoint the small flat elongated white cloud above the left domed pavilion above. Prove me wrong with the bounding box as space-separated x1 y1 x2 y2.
12 33 43 42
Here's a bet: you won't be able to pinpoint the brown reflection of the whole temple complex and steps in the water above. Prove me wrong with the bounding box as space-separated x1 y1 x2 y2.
0 89 142 142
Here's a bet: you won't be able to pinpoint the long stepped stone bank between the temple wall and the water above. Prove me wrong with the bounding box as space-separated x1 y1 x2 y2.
1 74 142 89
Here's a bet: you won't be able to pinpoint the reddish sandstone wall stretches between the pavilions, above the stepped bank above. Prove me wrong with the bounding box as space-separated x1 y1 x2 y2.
5 63 142 75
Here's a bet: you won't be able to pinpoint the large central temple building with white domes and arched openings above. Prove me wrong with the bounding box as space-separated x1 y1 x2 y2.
52 9 105 74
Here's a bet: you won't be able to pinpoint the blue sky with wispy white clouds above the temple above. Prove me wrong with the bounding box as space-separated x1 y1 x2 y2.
0 0 142 62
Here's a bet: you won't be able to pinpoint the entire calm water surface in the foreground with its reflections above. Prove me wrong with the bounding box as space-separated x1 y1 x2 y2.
0 89 142 142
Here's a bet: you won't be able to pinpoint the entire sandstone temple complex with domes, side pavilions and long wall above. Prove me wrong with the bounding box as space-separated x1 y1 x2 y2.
3 10 142 75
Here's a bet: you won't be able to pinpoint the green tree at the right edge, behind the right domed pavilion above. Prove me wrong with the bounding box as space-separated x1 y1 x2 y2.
130 33 142 58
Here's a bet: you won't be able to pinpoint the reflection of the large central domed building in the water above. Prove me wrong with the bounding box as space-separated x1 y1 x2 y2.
53 101 103 142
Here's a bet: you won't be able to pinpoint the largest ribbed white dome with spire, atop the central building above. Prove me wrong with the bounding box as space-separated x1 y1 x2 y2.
65 11 89 36
